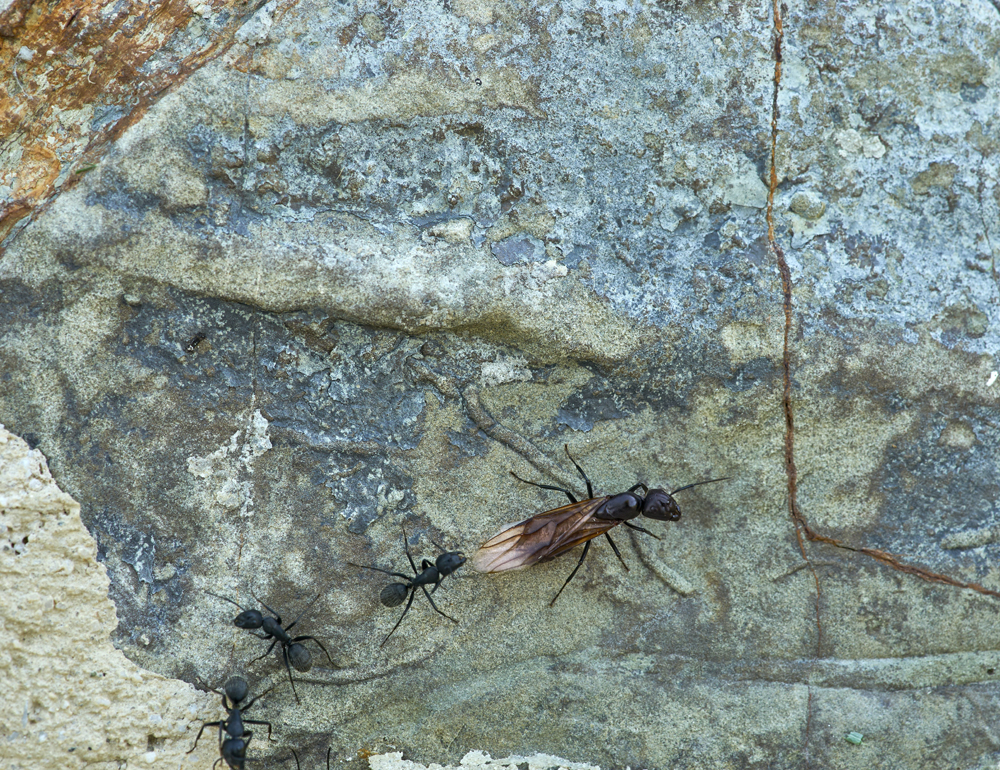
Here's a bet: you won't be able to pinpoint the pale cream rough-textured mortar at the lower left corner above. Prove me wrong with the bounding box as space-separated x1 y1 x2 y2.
0 425 218 768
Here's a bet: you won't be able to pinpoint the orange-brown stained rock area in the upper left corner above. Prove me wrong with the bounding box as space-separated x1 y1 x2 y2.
0 0 274 239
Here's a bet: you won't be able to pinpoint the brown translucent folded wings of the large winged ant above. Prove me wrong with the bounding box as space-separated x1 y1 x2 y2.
470 497 619 572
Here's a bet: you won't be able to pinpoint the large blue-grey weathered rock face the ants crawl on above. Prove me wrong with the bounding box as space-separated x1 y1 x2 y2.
0 2 1000 768
